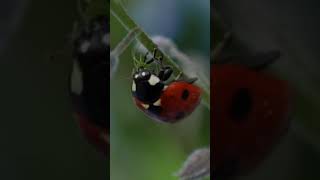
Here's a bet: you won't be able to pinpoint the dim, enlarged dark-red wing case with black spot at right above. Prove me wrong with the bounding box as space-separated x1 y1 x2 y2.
211 64 289 177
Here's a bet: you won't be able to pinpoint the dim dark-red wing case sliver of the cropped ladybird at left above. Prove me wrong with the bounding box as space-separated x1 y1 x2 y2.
74 113 109 155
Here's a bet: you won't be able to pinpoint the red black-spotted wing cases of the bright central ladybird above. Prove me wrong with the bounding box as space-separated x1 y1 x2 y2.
134 81 201 123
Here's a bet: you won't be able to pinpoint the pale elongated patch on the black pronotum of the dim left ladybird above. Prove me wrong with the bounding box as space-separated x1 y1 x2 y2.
71 61 83 95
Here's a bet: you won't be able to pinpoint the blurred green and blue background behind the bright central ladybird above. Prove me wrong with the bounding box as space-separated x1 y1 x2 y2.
110 0 210 180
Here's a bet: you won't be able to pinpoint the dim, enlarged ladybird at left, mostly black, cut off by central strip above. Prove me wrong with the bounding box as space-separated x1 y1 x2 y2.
70 15 110 154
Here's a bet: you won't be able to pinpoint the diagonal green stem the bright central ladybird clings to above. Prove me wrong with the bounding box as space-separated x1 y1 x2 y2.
110 0 210 109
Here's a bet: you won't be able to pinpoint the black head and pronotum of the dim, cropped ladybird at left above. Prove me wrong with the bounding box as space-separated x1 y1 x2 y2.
71 16 110 127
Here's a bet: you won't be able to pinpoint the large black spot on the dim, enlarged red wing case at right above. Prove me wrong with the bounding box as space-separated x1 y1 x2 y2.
230 88 253 122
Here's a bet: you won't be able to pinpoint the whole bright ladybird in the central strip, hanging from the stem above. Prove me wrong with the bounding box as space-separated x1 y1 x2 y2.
131 49 201 123
